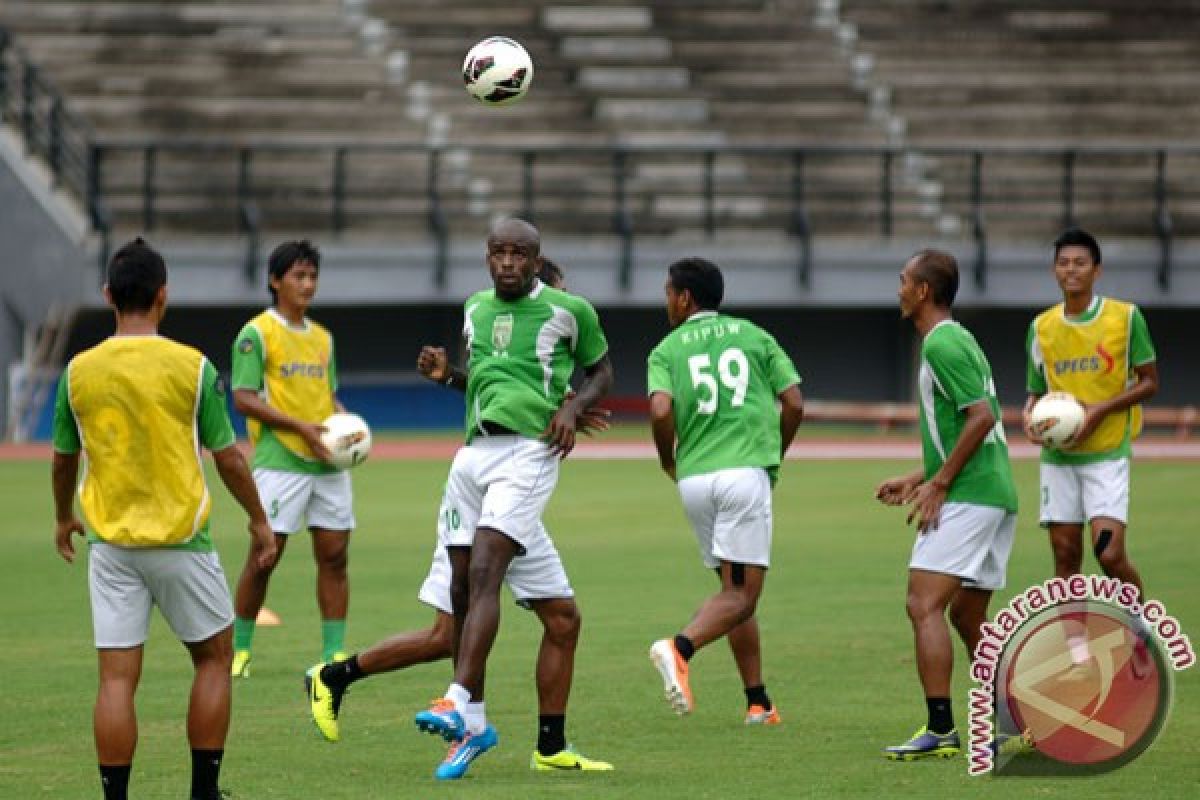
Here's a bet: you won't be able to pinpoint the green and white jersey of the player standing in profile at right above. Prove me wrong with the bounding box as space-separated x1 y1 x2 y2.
917 319 1016 511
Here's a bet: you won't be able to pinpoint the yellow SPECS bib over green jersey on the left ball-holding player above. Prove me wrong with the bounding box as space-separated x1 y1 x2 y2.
233 308 337 475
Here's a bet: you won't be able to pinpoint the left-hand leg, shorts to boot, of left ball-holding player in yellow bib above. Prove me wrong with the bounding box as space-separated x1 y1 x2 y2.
230 469 304 678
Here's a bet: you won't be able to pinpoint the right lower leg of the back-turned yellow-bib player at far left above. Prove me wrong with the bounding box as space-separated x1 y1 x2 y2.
185 627 233 800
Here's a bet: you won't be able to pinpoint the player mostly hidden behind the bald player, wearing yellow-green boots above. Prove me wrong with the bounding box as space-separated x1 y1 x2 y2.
306 259 612 771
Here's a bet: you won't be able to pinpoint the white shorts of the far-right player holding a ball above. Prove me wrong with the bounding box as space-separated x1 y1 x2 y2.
1039 458 1129 527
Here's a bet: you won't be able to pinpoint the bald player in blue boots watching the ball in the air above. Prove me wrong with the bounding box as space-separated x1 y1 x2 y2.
415 219 612 780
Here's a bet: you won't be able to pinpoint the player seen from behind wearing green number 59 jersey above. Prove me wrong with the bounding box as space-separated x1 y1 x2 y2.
647 258 804 724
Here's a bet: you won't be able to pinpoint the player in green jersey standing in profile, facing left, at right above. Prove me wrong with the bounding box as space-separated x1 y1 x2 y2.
875 249 1016 760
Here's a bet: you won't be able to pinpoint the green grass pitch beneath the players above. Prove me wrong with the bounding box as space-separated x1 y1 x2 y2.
0 453 1200 800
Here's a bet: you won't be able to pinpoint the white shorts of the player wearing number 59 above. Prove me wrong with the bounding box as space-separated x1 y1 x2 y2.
679 467 772 569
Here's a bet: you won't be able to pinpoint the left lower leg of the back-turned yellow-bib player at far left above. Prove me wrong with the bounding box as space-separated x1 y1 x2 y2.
92 645 142 800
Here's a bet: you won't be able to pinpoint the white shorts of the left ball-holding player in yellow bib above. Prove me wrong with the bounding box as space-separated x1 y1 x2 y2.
254 469 354 534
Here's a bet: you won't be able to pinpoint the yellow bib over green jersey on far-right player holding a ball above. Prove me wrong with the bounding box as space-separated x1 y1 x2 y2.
1025 295 1157 464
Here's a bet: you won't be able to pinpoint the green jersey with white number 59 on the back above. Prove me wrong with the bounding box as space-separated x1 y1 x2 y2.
646 311 800 481
